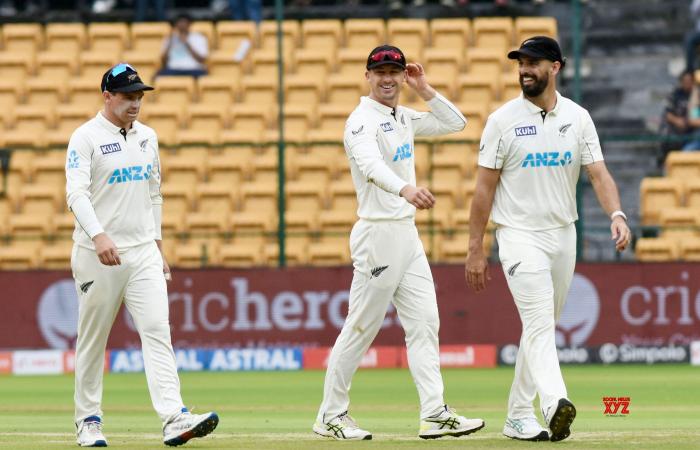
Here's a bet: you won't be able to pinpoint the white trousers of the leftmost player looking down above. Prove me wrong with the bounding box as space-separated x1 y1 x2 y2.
71 241 183 423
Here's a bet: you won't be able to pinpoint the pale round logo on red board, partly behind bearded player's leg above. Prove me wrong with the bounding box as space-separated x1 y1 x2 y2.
556 273 600 347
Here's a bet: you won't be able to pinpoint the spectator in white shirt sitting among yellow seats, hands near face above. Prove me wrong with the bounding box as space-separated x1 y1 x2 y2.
156 14 209 77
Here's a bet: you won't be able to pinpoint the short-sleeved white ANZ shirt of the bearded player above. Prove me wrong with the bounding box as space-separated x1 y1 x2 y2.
479 92 603 231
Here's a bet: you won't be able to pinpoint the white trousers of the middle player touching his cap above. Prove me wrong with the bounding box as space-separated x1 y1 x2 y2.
318 219 444 422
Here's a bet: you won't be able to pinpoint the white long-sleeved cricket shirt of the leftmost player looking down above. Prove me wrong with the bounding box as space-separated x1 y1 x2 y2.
66 112 163 249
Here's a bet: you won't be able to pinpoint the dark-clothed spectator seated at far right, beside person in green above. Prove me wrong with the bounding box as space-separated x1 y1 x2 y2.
659 72 694 159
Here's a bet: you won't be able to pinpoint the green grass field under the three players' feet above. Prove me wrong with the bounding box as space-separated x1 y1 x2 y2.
0 365 700 450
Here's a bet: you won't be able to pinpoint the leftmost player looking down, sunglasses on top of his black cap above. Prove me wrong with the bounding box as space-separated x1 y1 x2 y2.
66 64 219 447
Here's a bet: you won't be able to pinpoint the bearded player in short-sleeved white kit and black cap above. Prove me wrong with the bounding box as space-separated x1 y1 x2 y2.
465 36 630 441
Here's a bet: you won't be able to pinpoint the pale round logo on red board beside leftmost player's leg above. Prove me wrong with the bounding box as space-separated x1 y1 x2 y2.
37 279 78 350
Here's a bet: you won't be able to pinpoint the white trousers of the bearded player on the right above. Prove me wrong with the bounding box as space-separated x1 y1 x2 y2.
496 224 576 419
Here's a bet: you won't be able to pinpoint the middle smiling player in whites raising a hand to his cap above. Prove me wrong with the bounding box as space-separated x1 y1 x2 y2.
313 45 484 440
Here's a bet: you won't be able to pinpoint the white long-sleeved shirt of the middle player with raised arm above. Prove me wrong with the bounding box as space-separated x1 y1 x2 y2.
344 94 467 220
